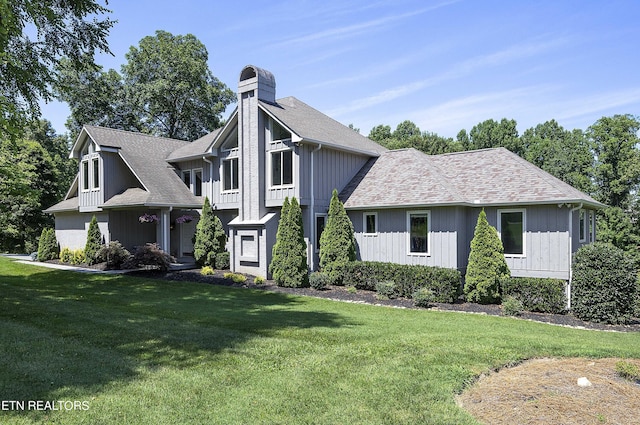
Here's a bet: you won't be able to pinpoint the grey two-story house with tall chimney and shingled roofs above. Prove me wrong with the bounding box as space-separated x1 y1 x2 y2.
47 65 604 280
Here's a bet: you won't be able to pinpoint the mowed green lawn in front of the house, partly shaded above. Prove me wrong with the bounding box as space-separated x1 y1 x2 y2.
0 258 640 424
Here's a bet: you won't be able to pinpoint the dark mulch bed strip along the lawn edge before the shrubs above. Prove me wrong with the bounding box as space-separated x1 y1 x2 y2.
129 269 640 332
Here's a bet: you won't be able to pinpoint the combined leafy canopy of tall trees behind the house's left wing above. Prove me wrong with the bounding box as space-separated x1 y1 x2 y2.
57 31 235 141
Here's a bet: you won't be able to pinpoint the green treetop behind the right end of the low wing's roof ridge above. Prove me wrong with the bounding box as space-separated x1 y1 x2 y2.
468 118 524 156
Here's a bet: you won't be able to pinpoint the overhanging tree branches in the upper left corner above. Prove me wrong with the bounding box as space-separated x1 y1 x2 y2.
0 0 114 138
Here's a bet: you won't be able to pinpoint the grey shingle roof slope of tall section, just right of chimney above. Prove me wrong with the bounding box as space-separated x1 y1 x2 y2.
260 97 387 156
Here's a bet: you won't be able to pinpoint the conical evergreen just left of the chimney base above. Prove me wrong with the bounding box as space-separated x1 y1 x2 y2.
193 197 227 267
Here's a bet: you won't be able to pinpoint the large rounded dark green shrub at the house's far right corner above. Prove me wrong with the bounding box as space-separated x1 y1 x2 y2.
571 242 637 324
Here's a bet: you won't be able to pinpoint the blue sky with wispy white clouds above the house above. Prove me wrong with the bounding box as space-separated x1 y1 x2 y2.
43 0 640 137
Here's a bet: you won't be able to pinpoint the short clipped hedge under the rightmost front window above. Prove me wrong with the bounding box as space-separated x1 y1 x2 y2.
500 277 567 314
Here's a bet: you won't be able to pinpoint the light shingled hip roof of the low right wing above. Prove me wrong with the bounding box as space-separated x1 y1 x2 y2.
340 148 604 209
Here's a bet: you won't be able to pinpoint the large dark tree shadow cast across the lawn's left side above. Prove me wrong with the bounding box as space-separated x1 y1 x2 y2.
0 263 349 400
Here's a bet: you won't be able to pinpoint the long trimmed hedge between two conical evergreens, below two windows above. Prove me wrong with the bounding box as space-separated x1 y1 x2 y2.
342 261 461 303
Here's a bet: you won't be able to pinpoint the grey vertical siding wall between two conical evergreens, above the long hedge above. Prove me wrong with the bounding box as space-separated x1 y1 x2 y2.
348 207 460 269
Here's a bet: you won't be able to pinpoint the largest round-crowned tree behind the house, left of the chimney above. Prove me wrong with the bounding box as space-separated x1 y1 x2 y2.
122 31 235 140
